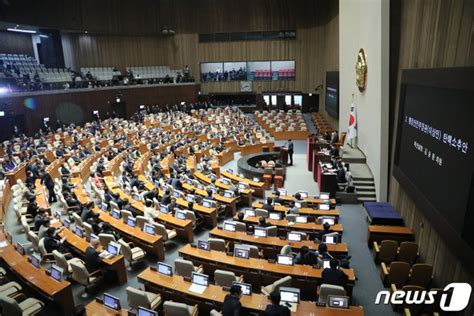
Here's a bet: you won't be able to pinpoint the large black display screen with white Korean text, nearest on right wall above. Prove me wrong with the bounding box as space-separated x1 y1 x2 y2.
394 70 474 256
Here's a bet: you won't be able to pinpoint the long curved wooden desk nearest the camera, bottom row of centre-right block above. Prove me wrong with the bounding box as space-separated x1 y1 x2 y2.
137 268 364 316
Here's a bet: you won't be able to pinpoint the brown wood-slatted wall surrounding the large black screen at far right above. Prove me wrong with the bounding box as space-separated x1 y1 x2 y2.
389 0 474 315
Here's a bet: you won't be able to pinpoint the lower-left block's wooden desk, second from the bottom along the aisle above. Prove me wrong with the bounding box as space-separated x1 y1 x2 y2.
58 228 127 285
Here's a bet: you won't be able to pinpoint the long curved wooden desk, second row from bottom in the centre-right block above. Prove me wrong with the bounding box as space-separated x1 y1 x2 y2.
179 244 355 299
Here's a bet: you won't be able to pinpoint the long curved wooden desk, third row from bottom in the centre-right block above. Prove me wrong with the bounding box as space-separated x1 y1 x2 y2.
209 227 349 259
